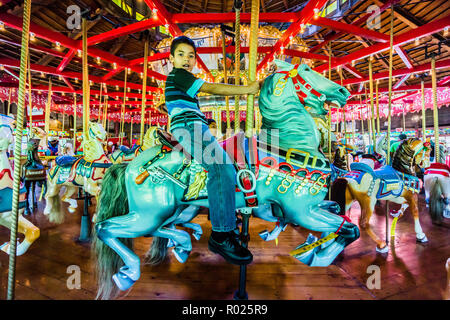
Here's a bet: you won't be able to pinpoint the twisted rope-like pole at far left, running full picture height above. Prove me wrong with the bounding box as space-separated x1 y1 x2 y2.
6 0 31 300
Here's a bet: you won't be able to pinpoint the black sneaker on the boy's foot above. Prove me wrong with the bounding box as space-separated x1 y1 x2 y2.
208 232 253 265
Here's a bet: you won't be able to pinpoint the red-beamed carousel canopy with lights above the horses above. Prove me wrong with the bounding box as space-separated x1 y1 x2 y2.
0 0 450 122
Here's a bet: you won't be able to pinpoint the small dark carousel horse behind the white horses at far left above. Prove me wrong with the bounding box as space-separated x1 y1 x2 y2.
22 138 47 215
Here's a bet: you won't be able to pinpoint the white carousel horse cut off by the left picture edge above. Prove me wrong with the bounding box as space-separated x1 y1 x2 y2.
0 116 40 256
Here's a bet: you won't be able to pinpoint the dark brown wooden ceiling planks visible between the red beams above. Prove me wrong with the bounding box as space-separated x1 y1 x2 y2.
0 0 450 110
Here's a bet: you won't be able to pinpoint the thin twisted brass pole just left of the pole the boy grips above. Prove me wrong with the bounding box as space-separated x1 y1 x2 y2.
234 0 242 133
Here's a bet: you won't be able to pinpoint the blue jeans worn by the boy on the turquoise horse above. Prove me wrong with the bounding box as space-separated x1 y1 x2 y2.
171 121 236 232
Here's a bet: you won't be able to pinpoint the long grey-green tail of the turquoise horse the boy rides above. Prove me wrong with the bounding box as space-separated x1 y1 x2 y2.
92 163 133 299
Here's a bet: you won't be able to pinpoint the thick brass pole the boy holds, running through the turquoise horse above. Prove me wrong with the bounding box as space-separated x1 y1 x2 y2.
234 0 259 300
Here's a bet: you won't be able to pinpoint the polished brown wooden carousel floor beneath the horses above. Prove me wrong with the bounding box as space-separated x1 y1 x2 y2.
0 189 450 300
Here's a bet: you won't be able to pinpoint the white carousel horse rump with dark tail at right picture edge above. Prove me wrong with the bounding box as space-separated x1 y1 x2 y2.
424 145 450 225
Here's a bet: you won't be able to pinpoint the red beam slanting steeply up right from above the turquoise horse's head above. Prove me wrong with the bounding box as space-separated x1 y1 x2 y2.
256 0 327 72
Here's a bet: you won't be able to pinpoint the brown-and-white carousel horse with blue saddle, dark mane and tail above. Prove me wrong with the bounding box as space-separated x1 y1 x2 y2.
331 138 431 252
